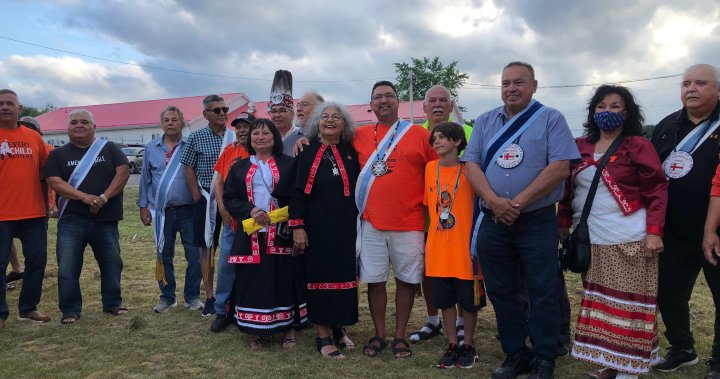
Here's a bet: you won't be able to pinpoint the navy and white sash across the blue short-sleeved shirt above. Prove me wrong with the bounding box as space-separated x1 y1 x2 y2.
470 100 545 259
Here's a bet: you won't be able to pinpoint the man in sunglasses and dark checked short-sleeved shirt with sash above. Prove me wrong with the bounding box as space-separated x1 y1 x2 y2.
180 95 235 316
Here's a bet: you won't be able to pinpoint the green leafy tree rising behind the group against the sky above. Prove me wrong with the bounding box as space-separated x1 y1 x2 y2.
393 57 470 111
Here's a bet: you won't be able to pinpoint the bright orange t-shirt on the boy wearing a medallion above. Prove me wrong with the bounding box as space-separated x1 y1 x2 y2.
423 161 482 280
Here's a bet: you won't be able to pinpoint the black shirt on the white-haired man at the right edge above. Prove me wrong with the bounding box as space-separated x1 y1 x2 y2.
652 105 720 243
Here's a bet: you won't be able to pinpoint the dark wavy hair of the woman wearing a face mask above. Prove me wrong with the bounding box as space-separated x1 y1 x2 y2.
583 84 645 142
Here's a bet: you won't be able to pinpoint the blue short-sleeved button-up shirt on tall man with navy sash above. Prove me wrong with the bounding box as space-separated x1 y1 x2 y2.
461 102 580 212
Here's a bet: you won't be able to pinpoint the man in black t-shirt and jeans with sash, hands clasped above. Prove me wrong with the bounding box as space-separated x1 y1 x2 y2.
44 109 130 324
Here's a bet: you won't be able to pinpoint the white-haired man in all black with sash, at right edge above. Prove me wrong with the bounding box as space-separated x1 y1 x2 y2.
652 64 720 378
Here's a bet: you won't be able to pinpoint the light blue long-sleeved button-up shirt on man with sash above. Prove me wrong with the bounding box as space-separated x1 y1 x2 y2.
137 135 195 209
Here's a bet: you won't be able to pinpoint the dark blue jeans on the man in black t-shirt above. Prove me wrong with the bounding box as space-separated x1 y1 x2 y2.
56 212 123 314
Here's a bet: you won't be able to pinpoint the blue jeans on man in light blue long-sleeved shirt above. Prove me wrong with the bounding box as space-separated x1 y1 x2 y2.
158 205 202 304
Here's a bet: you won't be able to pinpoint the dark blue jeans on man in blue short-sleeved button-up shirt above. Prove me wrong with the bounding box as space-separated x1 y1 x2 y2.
478 207 560 362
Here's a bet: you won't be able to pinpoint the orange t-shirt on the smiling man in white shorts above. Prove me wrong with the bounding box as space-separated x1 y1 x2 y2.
353 124 437 231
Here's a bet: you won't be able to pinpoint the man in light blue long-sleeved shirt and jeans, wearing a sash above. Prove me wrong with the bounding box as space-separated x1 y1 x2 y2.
137 106 203 313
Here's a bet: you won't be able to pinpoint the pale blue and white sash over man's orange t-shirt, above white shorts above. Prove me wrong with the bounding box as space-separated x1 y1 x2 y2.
355 120 412 256
